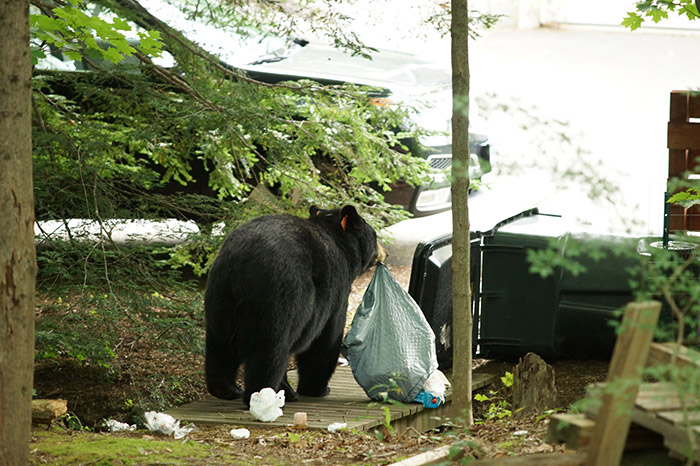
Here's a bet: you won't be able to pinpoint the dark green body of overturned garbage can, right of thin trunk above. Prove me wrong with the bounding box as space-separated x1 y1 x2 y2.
478 213 640 358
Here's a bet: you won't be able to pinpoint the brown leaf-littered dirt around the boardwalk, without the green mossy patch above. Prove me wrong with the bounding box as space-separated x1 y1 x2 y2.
33 267 608 465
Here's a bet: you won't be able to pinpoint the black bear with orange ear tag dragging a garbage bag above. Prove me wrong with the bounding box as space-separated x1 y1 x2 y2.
204 206 386 405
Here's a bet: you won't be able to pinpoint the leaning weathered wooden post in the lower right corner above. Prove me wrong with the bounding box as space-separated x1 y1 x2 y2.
586 301 661 466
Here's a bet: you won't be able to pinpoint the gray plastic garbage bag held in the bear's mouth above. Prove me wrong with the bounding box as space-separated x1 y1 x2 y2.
343 264 438 402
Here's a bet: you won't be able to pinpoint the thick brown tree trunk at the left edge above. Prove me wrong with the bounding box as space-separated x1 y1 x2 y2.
0 0 36 466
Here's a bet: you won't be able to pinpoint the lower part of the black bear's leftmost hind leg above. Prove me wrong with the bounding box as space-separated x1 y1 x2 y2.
204 338 243 400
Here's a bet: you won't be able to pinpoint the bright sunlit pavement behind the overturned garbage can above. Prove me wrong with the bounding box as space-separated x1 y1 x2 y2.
386 27 700 265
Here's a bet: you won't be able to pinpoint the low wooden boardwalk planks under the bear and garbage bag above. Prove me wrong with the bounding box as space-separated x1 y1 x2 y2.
167 367 496 433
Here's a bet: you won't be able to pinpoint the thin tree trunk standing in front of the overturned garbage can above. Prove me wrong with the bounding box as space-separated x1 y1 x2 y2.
451 0 473 425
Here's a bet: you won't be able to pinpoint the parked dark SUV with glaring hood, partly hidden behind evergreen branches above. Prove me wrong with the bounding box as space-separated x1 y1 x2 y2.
236 41 491 216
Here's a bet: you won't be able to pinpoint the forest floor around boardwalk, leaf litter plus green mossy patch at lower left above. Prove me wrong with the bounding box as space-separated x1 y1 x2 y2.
31 267 608 465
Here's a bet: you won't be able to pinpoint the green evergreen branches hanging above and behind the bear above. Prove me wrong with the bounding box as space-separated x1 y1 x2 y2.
32 0 426 251
